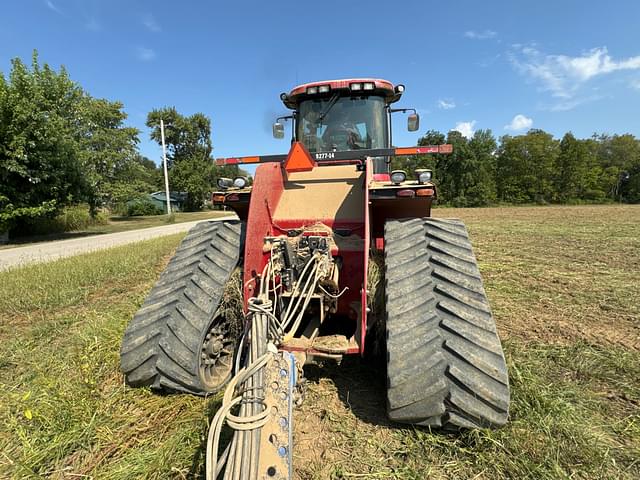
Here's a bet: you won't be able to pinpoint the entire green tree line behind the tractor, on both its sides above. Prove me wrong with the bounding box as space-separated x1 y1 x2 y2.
0 52 640 233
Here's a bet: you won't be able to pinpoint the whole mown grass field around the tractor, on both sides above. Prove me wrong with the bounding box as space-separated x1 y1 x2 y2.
0 206 640 480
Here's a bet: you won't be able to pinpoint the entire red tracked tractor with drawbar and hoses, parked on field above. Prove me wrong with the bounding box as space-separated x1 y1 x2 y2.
121 79 509 479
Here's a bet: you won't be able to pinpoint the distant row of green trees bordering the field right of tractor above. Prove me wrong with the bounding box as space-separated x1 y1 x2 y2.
393 129 640 207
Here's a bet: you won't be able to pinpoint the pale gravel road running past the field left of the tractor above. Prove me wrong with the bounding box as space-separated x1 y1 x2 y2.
0 217 233 271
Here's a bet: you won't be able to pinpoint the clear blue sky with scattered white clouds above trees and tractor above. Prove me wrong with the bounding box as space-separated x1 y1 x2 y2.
0 0 640 166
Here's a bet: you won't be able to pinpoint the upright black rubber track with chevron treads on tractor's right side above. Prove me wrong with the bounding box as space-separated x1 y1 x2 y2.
385 218 509 430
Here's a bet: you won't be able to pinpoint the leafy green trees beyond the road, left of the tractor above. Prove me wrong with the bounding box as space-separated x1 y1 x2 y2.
0 52 235 233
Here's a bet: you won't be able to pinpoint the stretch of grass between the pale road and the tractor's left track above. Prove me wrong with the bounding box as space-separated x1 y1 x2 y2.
0 235 218 479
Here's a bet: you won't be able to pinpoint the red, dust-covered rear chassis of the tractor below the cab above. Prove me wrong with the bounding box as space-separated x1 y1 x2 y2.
212 142 451 354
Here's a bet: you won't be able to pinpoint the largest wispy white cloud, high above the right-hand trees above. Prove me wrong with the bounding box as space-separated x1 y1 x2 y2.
510 44 640 99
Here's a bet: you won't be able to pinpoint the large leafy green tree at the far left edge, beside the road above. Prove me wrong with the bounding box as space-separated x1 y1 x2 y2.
0 52 89 229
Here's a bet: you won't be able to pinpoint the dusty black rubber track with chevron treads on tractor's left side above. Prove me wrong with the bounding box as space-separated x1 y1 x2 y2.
120 220 242 394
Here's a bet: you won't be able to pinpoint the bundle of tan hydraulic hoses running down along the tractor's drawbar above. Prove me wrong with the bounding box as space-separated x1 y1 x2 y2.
205 245 340 480
